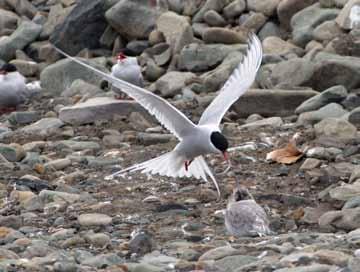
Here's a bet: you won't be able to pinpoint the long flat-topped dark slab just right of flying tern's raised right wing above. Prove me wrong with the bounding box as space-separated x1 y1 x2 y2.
233 89 318 117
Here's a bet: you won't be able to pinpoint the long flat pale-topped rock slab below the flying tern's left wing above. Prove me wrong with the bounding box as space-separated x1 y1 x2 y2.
59 97 149 125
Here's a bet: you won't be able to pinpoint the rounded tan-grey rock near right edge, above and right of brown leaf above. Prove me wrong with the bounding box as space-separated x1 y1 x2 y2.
315 116 357 140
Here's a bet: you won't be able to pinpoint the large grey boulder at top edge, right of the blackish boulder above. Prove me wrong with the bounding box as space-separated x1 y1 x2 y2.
105 0 160 40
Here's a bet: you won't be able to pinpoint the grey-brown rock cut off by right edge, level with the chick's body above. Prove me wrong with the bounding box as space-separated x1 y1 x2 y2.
319 208 360 231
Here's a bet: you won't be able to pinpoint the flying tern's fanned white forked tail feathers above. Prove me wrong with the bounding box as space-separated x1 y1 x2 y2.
106 151 220 196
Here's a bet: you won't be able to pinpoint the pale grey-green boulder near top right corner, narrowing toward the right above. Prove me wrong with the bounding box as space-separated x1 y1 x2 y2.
291 3 339 47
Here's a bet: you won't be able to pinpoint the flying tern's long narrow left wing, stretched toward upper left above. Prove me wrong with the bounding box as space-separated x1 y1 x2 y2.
55 47 196 140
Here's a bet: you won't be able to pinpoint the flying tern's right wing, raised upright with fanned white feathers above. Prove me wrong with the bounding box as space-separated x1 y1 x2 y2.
199 34 262 126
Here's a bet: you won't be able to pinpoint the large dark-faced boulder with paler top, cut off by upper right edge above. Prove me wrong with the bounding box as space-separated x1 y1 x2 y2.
309 52 360 91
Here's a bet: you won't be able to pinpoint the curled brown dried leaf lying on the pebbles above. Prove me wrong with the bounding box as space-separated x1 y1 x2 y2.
266 141 304 164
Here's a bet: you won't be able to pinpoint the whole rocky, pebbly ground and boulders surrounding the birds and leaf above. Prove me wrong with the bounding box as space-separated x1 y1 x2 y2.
0 0 360 272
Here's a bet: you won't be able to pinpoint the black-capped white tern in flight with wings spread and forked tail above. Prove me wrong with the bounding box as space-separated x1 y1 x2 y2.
56 34 262 197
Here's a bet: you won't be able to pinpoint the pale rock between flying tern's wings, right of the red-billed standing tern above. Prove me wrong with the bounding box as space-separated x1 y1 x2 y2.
156 71 195 97
